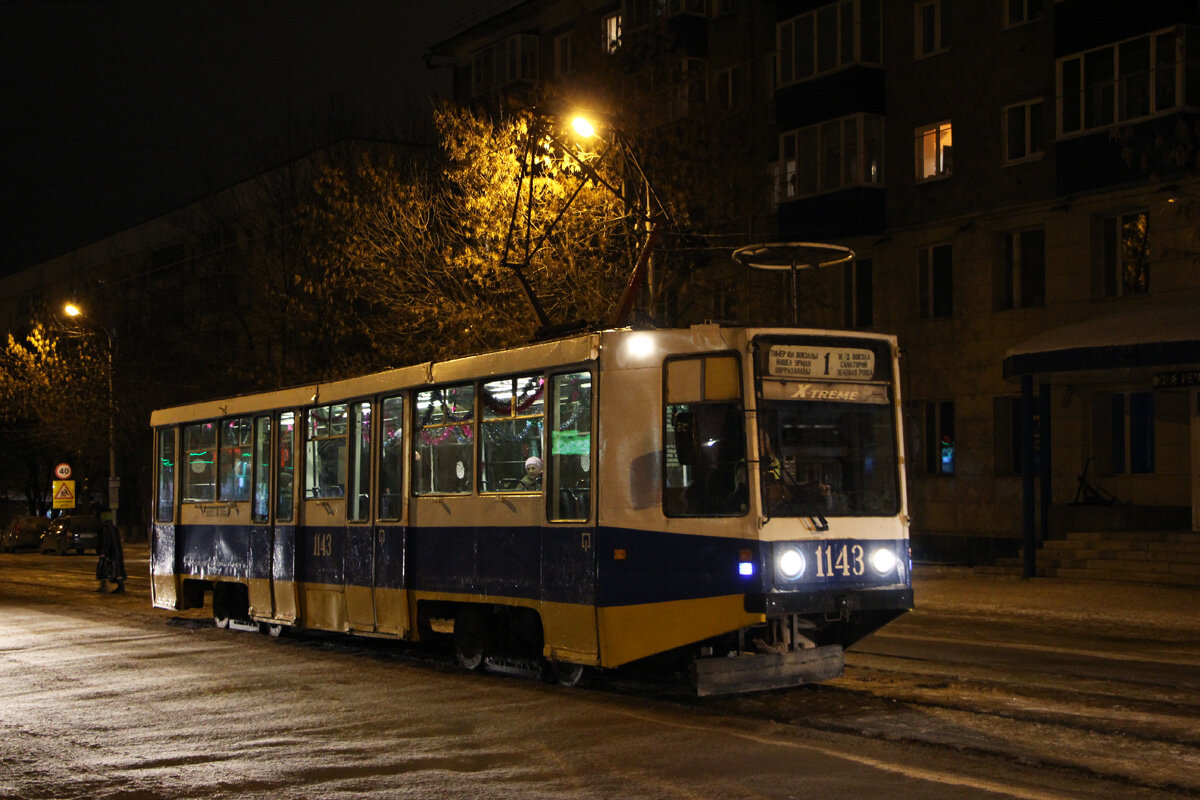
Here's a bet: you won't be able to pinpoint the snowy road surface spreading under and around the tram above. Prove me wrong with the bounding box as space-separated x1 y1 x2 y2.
0 548 1200 800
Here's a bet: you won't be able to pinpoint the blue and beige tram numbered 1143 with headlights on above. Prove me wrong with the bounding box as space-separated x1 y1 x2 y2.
151 325 912 694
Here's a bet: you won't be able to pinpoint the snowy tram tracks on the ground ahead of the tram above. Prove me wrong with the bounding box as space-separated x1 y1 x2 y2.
758 644 1200 796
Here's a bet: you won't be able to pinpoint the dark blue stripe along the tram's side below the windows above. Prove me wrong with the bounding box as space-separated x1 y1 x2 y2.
175 525 757 606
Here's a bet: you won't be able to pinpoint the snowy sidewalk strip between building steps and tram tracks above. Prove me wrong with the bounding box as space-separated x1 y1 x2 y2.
913 564 1200 639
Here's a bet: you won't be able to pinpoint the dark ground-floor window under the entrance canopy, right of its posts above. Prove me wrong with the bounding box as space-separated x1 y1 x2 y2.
1092 392 1154 475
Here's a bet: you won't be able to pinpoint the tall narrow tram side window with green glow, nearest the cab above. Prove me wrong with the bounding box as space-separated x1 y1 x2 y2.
546 372 594 522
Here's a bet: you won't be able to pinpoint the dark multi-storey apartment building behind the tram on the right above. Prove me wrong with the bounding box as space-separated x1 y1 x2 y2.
431 0 1200 558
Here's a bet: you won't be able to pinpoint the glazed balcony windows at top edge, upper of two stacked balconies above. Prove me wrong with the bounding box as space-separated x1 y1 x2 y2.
775 0 883 86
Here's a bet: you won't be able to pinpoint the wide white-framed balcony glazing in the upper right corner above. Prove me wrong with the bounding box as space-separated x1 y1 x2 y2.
1058 29 1180 134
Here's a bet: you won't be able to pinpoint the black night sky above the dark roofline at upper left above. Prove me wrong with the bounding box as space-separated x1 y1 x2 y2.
0 0 501 273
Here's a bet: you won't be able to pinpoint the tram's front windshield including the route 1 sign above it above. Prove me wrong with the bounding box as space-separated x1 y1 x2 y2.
757 333 900 517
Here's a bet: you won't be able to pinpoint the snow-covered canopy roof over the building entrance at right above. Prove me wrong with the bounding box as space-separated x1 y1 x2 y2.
1004 297 1200 380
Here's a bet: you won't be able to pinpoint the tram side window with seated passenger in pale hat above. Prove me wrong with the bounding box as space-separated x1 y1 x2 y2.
479 375 546 492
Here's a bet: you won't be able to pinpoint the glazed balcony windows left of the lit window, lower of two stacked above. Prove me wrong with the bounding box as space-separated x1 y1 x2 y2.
775 114 883 201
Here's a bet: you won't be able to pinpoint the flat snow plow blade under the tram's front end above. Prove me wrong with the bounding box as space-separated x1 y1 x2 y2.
692 644 846 697
